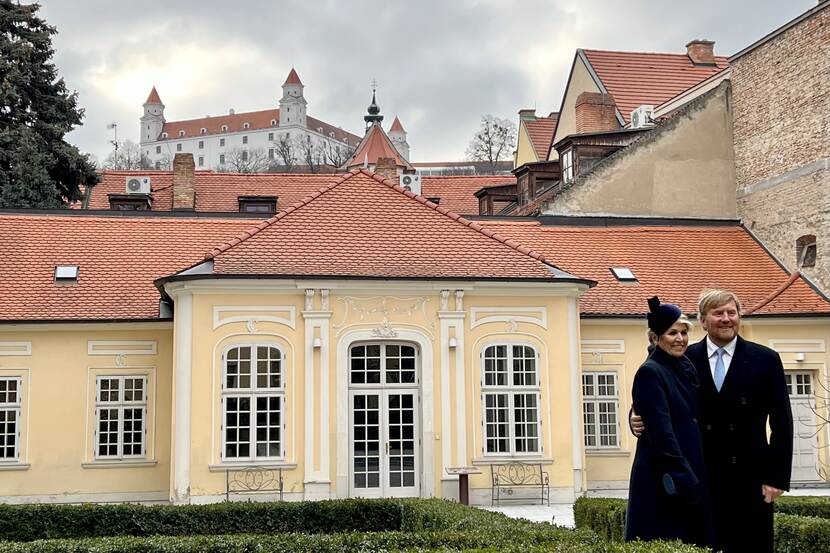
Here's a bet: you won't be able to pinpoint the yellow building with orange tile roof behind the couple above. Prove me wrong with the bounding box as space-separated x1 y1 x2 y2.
0 171 830 503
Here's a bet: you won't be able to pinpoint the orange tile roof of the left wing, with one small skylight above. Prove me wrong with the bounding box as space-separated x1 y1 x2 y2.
0 214 253 321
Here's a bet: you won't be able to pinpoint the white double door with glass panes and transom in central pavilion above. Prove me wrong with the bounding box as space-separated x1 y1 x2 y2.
349 344 420 497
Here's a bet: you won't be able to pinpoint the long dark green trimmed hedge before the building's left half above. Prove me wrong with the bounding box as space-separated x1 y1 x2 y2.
0 499 403 541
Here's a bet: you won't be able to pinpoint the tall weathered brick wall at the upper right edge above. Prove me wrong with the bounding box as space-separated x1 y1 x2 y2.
730 8 830 292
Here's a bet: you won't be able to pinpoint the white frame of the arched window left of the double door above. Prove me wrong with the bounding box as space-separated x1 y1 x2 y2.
219 342 287 463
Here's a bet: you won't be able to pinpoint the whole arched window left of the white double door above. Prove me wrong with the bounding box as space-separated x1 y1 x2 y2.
222 344 285 461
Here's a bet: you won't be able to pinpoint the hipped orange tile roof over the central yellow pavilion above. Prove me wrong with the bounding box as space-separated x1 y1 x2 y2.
207 170 575 281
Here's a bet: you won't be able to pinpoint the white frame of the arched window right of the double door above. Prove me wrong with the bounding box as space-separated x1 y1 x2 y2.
479 342 544 458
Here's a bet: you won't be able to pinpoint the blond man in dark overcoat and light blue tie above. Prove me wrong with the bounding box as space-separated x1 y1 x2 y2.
632 290 793 553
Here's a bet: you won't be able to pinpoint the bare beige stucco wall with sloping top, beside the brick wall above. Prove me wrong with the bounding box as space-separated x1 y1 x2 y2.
542 84 736 218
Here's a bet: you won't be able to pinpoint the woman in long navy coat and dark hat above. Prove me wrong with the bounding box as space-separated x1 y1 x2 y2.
625 297 714 546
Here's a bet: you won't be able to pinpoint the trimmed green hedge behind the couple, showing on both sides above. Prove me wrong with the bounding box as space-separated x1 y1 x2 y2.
574 497 830 553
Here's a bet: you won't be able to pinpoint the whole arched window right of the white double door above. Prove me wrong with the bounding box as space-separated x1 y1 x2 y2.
481 343 542 455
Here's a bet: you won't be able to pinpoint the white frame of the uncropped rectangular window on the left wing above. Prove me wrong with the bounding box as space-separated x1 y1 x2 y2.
93 374 149 461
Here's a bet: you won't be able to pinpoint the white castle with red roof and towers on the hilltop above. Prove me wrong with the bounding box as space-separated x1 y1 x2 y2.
140 68 362 172
